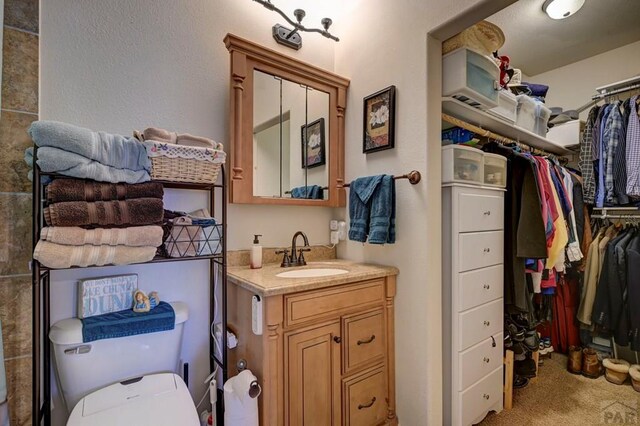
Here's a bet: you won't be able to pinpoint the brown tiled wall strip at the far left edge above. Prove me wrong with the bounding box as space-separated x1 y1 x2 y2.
0 0 38 425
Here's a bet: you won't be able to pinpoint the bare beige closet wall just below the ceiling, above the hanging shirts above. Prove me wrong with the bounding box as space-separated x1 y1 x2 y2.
528 41 640 120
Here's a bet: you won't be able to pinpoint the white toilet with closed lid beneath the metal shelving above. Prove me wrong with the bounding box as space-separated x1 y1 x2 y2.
49 302 200 426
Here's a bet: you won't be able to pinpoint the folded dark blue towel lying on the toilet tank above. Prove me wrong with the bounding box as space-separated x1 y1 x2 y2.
81 302 176 343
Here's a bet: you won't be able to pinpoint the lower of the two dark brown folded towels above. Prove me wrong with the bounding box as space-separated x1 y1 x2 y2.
44 198 164 228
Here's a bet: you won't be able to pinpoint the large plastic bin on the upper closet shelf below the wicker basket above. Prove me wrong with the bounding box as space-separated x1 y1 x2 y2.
442 48 500 109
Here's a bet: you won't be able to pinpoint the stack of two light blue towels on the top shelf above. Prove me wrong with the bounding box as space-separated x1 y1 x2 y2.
25 121 151 183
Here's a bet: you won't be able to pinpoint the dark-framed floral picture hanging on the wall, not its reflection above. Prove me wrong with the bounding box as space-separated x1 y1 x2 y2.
362 86 396 153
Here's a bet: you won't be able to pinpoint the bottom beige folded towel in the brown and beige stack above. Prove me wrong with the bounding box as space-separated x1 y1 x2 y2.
33 240 156 269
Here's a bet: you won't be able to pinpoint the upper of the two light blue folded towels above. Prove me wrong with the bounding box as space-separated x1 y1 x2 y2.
29 121 151 171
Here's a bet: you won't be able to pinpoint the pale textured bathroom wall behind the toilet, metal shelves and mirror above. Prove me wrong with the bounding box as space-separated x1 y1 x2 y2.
38 0 340 421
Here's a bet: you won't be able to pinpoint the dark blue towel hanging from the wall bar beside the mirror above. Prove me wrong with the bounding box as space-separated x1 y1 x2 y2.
349 175 396 244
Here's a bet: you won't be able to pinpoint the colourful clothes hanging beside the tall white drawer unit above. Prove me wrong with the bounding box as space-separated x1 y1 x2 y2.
483 142 590 328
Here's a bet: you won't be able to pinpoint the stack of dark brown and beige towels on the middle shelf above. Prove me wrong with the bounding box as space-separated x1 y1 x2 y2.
33 178 164 268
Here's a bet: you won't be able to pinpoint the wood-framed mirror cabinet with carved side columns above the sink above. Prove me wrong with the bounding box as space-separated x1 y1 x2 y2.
224 34 349 207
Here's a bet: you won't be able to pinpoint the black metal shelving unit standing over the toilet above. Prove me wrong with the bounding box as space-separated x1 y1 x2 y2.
31 154 228 426
